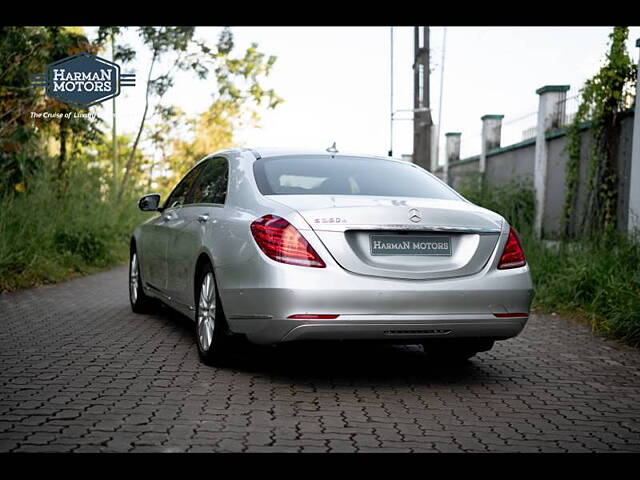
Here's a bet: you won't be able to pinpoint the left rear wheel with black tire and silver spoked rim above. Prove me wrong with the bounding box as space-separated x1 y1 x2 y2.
195 263 232 366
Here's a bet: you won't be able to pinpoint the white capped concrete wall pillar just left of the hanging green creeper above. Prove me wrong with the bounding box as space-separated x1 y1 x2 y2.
533 85 569 238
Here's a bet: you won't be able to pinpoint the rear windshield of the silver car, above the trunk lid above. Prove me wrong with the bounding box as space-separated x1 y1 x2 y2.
253 155 460 200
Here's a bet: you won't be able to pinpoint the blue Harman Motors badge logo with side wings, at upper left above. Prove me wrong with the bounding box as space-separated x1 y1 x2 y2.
31 53 136 108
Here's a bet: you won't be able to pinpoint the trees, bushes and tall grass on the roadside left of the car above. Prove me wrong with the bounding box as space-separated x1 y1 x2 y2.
0 26 281 292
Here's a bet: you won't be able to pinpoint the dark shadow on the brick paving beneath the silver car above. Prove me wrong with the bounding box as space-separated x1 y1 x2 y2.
153 306 492 386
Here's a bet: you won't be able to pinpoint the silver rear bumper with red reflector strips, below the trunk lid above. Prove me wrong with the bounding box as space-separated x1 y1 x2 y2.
216 248 533 344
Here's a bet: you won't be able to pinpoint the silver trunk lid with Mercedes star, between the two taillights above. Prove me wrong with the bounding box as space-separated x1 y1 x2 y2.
270 195 503 279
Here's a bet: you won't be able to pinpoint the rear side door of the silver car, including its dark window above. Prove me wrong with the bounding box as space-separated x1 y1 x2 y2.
167 157 229 307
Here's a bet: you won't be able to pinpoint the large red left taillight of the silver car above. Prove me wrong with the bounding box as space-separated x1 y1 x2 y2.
251 215 326 268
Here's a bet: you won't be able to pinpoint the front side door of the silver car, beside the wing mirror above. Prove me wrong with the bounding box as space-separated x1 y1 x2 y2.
142 164 204 295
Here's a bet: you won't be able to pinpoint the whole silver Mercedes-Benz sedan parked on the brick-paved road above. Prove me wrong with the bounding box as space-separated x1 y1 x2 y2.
129 148 533 364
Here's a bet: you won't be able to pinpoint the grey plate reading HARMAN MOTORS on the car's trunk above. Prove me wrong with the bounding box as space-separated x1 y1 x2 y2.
369 235 452 256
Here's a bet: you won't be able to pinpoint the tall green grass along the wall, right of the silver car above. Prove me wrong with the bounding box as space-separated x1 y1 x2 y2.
461 176 640 347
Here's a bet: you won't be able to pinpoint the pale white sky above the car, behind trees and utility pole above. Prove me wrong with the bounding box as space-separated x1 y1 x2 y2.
86 27 640 169
